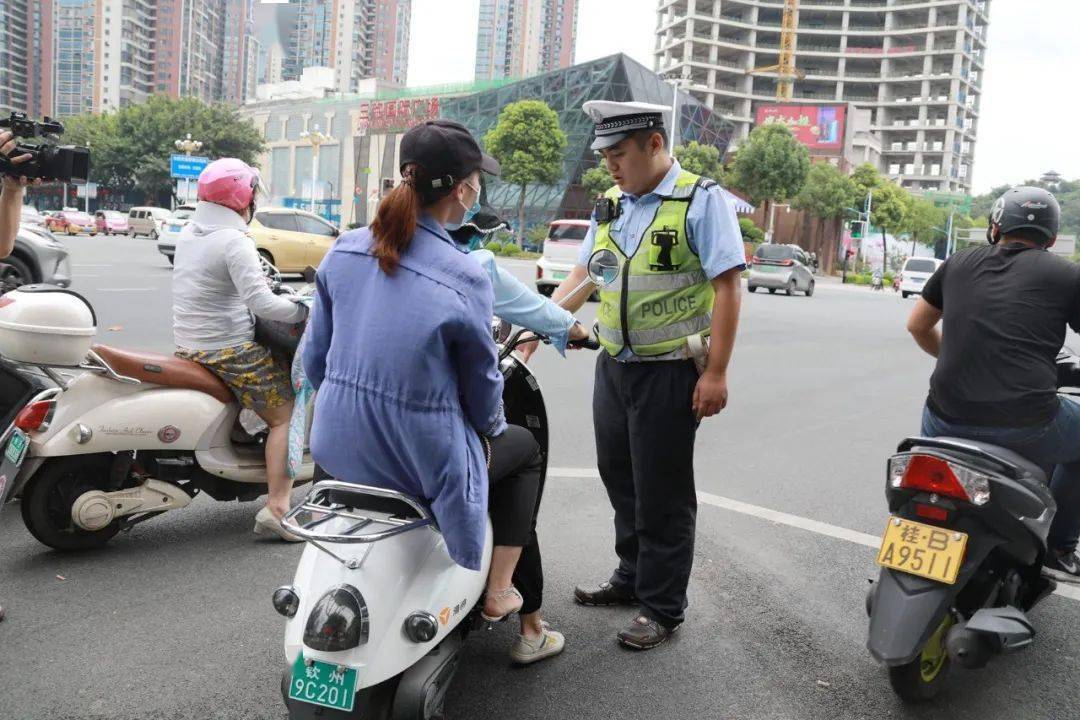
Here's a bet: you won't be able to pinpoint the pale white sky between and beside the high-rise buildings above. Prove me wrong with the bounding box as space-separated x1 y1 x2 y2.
408 0 1080 193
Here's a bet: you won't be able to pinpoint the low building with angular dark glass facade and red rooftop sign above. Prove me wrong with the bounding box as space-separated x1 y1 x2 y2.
241 54 734 226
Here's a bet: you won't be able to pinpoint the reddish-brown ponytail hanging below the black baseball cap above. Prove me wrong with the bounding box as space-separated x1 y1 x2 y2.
369 164 449 275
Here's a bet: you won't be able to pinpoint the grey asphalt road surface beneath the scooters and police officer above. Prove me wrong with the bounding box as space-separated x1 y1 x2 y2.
0 237 1080 720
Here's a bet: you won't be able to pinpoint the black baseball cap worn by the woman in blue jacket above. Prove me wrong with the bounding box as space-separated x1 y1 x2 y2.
401 120 501 189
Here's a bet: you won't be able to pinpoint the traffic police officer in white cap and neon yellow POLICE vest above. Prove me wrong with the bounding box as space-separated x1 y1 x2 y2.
533 100 745 650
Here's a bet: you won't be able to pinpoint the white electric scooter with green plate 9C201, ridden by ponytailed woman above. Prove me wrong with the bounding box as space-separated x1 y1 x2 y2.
273 249 620 720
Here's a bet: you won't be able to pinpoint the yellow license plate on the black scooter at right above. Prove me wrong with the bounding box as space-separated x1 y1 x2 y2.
877 517 968 585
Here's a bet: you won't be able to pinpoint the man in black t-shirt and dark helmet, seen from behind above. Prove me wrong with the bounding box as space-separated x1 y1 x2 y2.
907 188 1080 582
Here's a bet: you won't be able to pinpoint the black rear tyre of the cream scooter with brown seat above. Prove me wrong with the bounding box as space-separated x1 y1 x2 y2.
21 456 120 552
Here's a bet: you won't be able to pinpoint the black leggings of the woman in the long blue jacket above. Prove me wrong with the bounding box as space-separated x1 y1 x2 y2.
487 425 543 613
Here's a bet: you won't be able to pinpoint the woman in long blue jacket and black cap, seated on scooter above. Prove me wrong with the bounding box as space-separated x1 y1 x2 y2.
303 120 563 662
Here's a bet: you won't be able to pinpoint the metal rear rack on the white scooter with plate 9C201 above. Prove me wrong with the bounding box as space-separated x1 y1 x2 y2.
282 480 437 569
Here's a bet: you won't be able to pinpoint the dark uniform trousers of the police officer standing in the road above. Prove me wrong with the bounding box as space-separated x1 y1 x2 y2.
593 352 698 627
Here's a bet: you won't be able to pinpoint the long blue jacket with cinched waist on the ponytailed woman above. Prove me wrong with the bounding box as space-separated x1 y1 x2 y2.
303 216 505 570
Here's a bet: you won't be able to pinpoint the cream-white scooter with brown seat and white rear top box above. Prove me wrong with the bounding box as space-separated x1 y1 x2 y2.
0 267 314 551
